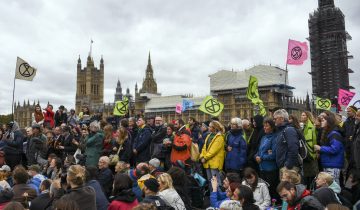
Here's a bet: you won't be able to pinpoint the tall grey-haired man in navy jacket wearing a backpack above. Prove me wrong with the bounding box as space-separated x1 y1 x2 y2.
274 109 301 172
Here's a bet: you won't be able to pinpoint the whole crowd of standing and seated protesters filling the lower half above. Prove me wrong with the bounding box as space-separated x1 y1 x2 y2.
0 105 360 210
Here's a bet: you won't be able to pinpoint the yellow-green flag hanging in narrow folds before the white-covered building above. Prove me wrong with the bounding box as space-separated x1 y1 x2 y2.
246 76 266 116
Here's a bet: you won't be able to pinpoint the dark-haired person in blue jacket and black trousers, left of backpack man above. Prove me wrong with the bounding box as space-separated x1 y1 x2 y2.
255 118 279 201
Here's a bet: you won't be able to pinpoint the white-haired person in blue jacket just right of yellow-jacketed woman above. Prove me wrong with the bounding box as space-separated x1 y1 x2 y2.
225 118 247 174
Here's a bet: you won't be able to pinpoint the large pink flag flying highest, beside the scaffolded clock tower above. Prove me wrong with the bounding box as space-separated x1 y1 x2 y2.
286 39 308 65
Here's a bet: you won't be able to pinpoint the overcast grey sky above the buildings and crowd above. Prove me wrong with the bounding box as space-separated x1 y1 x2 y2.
0 0 360 114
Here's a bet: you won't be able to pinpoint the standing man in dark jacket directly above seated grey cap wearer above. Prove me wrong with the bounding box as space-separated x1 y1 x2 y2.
150 117 166 158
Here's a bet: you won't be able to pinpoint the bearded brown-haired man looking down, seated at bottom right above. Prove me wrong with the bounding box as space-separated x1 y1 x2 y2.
277 181 324 210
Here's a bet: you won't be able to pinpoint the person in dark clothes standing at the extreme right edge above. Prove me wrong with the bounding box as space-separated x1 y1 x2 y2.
344 106 358 174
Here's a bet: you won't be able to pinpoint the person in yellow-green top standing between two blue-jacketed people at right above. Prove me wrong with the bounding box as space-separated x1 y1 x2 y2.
301 111 319 187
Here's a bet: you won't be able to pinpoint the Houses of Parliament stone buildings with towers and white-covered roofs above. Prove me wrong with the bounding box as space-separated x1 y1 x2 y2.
14 49 309 127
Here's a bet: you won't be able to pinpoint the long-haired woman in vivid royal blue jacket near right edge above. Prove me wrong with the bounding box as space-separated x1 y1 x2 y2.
314 115 344 184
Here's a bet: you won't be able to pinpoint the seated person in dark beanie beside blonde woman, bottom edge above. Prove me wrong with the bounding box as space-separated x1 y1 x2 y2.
141 178 169 210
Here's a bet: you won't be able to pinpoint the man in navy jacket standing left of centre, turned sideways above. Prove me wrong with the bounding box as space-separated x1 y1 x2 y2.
133 117 152 163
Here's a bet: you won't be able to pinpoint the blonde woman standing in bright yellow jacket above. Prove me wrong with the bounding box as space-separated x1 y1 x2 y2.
200 121 225 188
